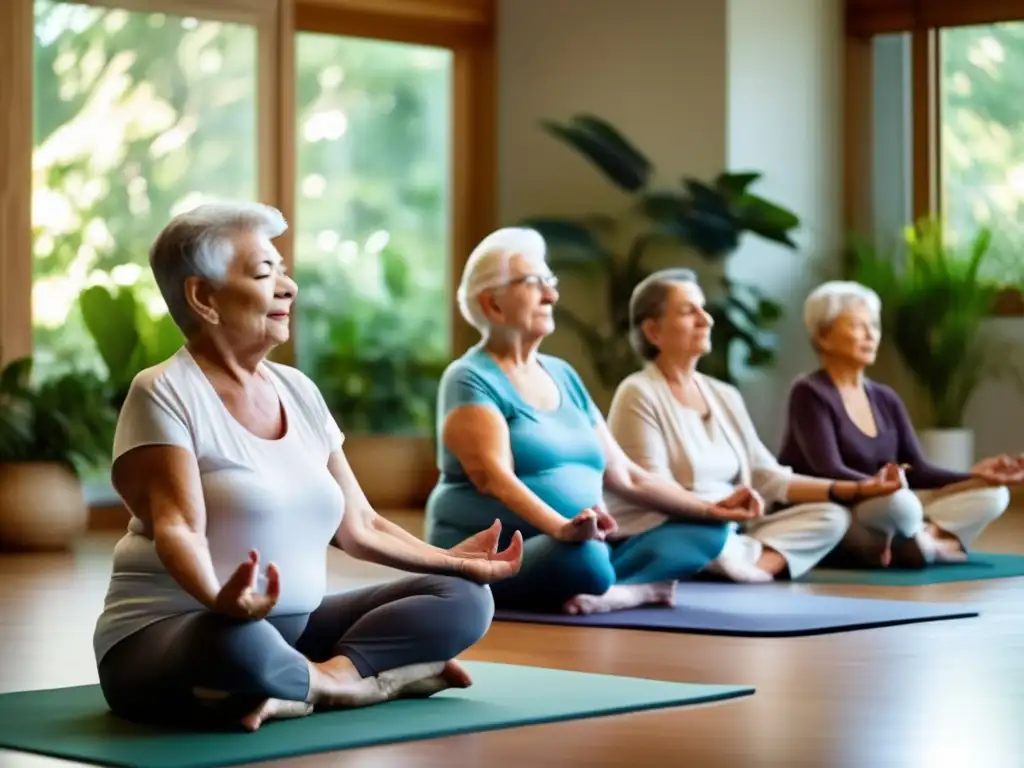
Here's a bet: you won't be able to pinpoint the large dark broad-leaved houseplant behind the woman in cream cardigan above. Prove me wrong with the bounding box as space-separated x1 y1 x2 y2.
520 115 800 388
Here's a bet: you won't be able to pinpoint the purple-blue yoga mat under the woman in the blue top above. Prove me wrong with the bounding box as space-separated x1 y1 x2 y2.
495 582 978 637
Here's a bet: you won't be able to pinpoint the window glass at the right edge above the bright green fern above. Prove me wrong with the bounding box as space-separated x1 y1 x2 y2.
939 22 1024 283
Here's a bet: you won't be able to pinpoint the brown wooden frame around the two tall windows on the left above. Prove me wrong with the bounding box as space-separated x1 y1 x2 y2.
0 0 497 361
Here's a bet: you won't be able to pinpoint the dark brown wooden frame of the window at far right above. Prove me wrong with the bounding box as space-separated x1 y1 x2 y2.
844 6 1024 316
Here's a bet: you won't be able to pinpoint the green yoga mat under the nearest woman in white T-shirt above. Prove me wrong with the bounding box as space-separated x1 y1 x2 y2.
0 662 754 768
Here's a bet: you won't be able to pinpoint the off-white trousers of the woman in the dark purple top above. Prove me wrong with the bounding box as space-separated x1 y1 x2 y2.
853 485 1010 551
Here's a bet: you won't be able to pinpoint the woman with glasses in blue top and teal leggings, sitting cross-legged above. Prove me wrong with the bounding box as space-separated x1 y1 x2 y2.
426 227 761 613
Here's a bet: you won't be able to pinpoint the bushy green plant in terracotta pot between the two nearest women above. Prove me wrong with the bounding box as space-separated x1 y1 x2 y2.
296 245 451 509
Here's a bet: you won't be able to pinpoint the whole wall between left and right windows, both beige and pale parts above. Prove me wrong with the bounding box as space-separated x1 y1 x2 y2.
499 0 843 447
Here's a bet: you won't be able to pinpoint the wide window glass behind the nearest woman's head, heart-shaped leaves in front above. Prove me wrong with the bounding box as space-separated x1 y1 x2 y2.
32 0 258 495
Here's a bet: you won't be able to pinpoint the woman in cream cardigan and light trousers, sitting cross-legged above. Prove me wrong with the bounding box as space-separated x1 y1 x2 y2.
606 269 901 583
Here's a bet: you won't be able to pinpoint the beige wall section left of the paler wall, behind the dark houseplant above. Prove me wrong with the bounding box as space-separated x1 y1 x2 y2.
499 0 726 407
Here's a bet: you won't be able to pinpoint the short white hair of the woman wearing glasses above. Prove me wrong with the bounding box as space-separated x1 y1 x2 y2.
457 226 548 334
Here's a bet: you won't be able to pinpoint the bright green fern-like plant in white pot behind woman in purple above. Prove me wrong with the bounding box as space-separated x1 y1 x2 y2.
848 217 1021 471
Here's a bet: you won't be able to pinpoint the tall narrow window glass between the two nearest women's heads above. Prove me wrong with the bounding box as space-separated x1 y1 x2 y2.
293 33 453 434
